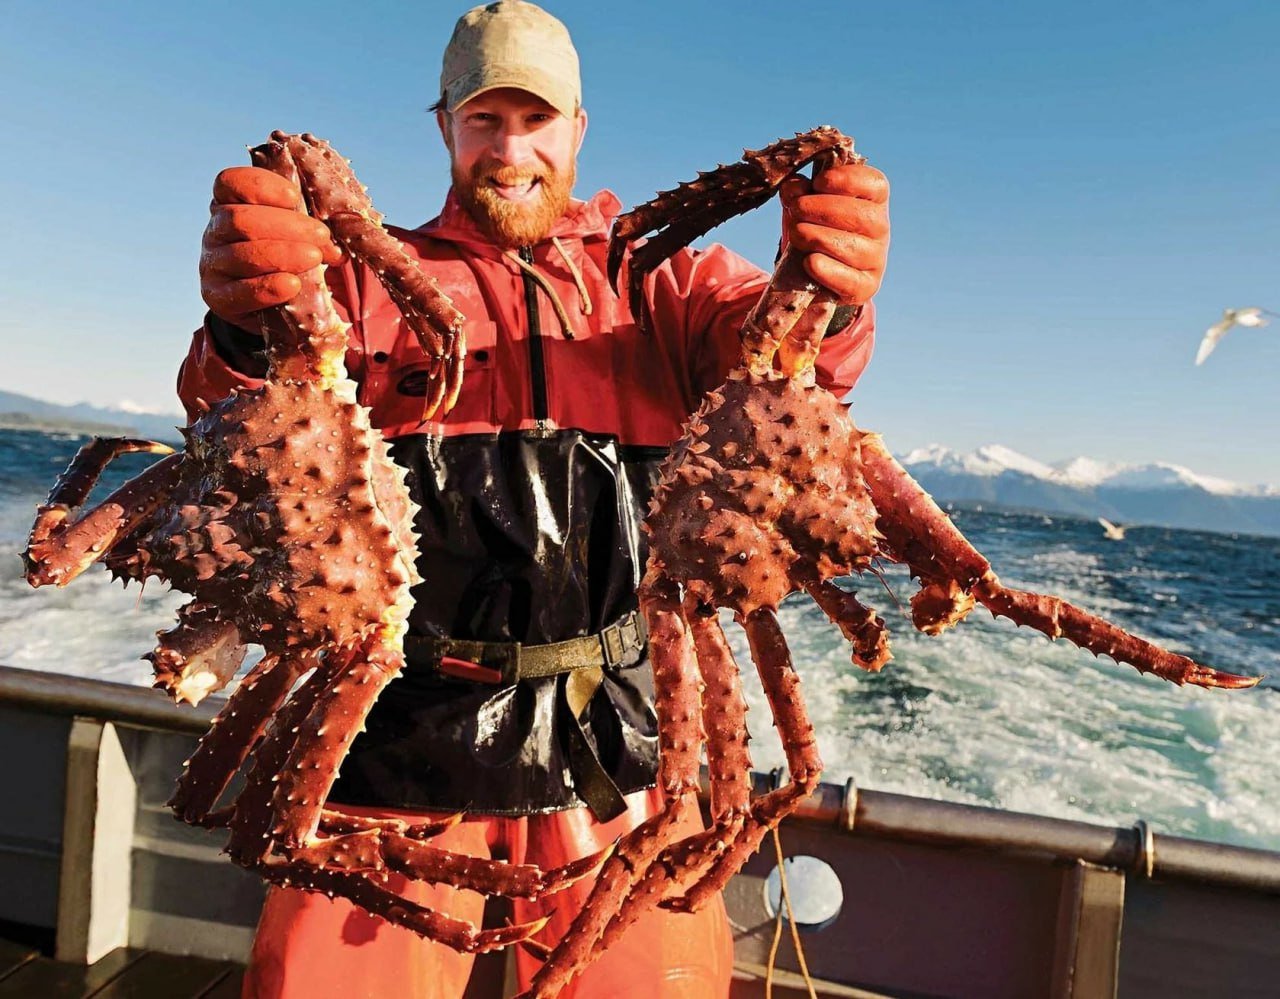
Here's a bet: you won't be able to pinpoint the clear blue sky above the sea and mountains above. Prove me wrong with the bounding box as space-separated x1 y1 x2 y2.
0 0 1280 484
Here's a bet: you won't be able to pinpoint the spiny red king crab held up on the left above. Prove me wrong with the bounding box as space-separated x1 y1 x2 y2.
23 132 602 952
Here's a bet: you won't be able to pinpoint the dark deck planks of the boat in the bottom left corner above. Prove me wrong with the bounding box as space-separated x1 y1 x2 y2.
0 925 244 999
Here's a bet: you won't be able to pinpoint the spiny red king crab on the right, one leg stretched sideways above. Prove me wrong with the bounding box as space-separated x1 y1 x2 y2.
531 128 1258 995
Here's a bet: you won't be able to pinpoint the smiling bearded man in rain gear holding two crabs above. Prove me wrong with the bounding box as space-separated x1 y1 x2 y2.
189 0 888 999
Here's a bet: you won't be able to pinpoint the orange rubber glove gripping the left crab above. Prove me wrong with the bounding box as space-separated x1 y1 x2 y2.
200 167 342 327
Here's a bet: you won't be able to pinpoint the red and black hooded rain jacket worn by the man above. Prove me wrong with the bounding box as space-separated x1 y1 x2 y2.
178 191 874 817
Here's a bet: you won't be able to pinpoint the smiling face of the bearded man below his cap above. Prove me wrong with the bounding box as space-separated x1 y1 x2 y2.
436 88 586 247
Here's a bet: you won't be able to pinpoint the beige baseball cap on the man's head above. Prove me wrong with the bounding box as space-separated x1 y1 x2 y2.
440 0 582 118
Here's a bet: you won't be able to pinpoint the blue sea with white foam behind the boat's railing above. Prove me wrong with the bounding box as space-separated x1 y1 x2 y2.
0 430 1280 849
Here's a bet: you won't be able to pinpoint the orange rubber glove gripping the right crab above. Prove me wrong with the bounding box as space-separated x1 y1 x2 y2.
780 163 888 305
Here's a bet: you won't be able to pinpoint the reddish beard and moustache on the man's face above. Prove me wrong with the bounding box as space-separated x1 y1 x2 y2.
453 160 576 247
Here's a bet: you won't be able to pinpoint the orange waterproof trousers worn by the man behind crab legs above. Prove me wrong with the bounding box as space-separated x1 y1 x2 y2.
243 790 733 999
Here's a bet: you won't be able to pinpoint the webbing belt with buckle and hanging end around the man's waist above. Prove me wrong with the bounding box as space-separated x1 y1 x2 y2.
404 611 649 822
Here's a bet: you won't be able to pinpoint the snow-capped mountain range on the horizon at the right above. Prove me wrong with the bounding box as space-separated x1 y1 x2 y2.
900 444 1280 534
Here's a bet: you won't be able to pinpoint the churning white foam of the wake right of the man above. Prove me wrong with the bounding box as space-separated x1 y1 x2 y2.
722 586 1280 849
